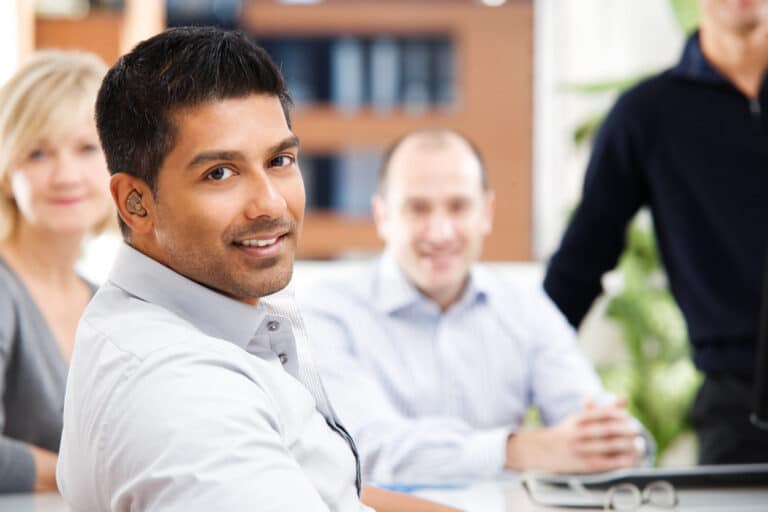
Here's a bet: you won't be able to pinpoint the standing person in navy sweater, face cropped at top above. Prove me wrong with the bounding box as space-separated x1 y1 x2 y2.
544 0 768 464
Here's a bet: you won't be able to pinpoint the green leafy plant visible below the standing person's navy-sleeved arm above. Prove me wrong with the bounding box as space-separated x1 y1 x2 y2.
600 219 701 457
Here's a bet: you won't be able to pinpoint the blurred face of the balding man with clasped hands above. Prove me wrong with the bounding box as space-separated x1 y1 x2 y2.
373 138 493 308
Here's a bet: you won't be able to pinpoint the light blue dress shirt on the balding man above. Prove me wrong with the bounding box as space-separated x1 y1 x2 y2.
301 253 612 482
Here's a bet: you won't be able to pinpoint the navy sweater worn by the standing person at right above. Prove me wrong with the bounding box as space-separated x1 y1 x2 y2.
544 34 768 375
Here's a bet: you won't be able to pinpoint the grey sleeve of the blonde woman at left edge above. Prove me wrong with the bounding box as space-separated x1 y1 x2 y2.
0 288 35 493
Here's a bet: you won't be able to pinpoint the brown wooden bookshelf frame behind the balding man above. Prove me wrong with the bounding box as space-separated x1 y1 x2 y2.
241 0 533 260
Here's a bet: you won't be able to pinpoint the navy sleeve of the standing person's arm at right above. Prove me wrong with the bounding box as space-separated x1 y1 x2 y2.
544 87 652 327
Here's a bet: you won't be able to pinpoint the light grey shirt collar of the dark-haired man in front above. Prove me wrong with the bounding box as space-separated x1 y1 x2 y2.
109 243 267 348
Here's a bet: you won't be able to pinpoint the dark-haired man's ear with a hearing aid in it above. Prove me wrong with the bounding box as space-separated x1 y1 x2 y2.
109 172 155 234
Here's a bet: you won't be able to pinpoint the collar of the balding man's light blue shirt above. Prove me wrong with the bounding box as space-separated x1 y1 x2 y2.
373 251 492 314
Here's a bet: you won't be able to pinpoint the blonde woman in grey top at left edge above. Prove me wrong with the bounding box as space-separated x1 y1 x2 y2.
0 51 113 492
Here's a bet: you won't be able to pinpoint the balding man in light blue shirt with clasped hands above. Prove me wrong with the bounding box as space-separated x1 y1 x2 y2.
303 130 646 482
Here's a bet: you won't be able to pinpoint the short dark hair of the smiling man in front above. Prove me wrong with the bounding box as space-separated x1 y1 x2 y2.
96 27 292 235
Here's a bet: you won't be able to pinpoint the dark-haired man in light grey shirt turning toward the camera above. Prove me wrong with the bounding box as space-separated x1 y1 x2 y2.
57 27 460 512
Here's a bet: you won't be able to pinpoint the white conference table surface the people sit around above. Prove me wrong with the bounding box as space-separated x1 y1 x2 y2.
0 476 768 512
